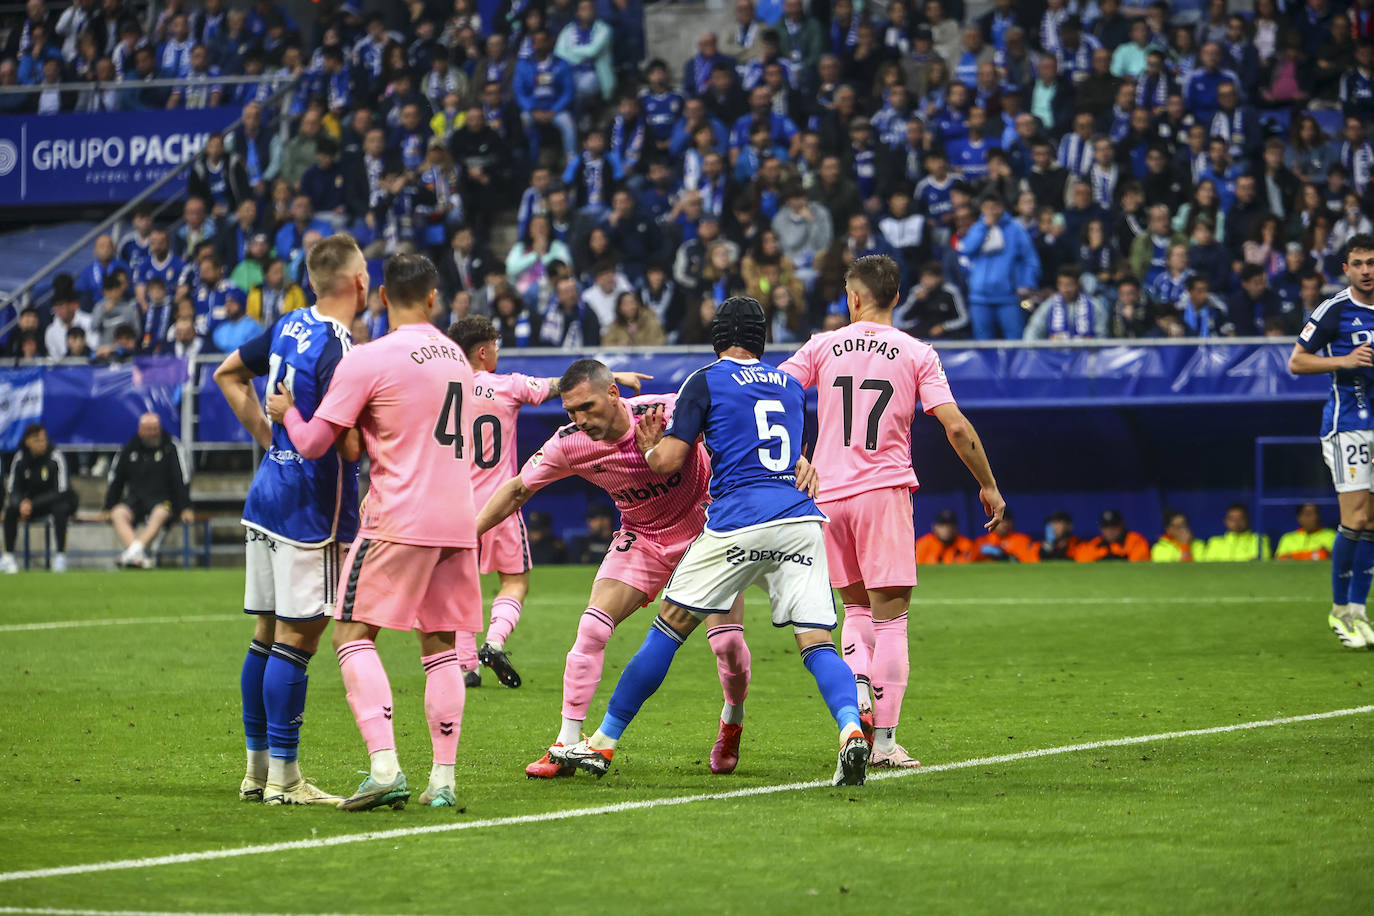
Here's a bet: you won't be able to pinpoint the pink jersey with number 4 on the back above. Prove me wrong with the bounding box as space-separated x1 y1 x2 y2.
315 324 477 547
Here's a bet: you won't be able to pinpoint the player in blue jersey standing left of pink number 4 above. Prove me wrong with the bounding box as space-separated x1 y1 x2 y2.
214 235 368 805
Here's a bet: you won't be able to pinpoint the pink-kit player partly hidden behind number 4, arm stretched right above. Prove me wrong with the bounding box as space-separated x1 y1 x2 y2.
448 314 653 687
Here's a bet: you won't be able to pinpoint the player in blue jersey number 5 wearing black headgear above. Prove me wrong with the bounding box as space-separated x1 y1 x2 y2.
548 297 868 786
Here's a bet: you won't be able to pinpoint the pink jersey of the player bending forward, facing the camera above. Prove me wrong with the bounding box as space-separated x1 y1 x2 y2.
519 394 710 545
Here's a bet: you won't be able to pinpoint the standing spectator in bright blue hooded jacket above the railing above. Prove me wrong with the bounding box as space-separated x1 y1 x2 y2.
959 196 1040 341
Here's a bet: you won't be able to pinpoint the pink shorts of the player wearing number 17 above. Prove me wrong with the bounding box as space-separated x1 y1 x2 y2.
819 486 916 588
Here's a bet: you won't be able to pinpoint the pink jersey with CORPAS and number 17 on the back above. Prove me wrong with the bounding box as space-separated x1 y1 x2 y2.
779 321 954 501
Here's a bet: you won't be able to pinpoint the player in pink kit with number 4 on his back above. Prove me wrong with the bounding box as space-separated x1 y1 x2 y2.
268 254 482 810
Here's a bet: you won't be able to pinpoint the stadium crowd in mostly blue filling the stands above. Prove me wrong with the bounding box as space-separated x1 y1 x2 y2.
0 0 1374 358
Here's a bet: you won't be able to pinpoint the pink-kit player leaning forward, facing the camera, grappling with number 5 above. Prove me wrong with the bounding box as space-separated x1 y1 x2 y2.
477 360 749 779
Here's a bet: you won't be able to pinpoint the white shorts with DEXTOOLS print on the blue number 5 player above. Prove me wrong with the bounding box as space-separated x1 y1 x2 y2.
664 519 835 630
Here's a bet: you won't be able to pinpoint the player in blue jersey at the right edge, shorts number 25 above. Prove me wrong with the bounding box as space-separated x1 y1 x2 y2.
1289 233 1374 648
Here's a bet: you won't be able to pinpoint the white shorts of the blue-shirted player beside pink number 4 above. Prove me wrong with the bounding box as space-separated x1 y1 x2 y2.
243 527 339 621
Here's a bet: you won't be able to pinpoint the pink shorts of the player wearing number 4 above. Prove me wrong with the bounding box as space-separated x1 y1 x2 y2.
334 540 482 633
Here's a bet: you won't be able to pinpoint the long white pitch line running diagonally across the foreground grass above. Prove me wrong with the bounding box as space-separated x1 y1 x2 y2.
0 706 1374 884
